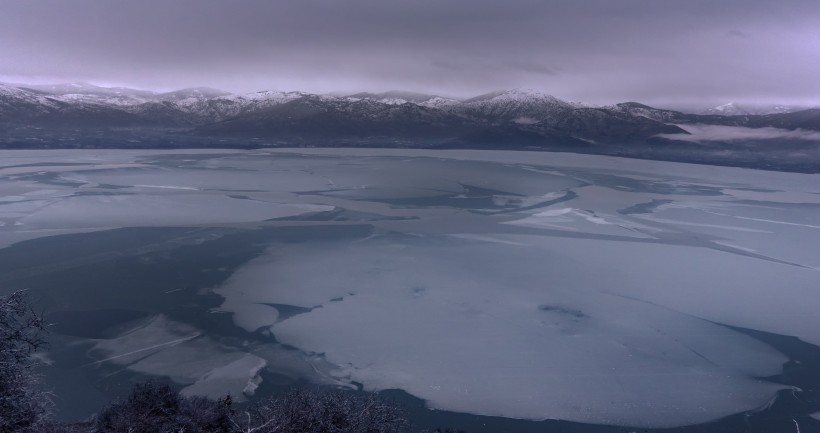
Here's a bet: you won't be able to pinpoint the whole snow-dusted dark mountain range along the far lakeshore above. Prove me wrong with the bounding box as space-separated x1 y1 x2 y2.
0 84 820 170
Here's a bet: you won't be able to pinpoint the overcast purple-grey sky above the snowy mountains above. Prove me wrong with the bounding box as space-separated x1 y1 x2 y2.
0 0 820 105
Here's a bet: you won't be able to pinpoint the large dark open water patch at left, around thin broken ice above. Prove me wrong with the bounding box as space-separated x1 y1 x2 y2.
0 225 372 420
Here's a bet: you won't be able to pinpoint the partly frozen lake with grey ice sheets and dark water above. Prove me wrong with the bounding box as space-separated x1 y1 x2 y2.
0 149 820 427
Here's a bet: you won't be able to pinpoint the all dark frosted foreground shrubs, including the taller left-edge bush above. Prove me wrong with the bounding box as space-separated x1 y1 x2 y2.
0 291 464 433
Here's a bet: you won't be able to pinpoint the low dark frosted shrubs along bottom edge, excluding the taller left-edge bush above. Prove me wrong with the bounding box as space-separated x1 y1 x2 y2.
82 383 407 433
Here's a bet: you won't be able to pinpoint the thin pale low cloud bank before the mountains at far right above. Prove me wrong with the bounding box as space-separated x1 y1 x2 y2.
658 124 820 142
